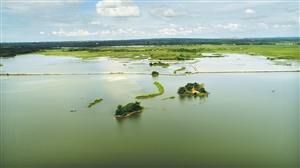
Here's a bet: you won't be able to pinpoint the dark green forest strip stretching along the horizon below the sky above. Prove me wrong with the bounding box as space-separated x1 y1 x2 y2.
0 37 300 57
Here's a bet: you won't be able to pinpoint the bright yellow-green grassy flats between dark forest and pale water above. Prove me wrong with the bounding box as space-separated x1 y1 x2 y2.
35 45 300 60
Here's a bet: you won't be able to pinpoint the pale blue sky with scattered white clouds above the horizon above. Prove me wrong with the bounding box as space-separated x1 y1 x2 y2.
1 0 299 42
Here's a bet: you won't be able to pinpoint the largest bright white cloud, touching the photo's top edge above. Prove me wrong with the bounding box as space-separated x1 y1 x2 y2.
96 0 141 17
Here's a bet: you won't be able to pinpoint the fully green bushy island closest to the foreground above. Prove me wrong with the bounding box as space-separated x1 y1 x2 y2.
114 101 145 117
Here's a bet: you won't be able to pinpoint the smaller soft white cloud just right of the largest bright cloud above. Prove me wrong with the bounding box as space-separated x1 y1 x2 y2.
149 7 187 18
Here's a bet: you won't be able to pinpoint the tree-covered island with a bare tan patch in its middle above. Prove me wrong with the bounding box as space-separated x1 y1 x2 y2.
177 82 209 97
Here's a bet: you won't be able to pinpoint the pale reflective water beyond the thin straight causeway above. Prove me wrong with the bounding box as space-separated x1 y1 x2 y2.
0 54 299 74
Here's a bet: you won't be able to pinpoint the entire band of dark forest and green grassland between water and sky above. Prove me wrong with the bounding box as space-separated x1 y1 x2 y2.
0 37 299 60
